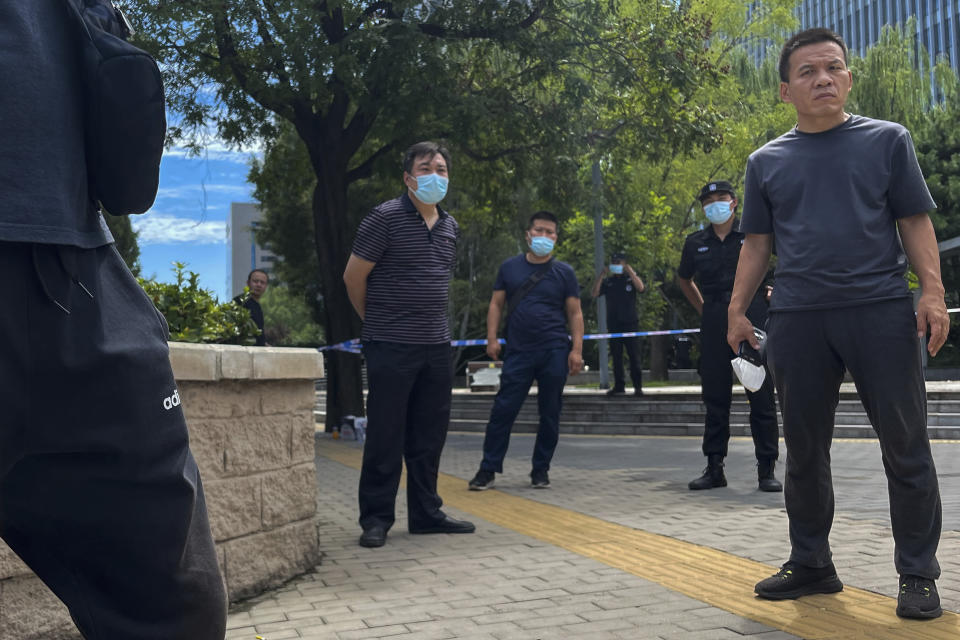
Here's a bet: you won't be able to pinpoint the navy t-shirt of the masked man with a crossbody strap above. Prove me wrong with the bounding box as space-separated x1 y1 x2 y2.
493 254 580 351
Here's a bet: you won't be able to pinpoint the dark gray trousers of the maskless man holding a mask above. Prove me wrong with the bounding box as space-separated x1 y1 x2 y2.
767 299 941 579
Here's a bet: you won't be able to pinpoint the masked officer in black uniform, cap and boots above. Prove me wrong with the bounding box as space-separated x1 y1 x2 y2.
677 180 783 491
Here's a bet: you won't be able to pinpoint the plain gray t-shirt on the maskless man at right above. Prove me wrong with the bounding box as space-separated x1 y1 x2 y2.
740 115 936 311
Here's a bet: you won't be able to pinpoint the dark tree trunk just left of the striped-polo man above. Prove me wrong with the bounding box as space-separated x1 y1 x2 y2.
313 168 365 431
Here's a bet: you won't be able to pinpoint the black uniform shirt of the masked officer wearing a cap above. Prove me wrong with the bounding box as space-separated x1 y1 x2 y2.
677 222 745 297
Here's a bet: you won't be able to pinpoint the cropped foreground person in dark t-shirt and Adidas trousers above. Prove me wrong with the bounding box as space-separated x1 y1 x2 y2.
0 0 227 640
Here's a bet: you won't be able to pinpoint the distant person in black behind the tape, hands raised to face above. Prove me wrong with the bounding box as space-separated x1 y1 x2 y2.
591 252 645 396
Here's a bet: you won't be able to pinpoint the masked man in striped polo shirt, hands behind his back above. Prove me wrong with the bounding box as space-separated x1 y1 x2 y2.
343 142 474 547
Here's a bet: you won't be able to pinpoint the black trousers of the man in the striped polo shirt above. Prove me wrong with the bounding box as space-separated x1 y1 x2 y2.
359 341 453 529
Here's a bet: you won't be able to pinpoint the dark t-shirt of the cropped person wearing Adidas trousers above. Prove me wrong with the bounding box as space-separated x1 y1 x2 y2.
0 0 113 248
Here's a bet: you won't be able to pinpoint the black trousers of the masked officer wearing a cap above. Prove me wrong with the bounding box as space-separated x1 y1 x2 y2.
700 298 780 460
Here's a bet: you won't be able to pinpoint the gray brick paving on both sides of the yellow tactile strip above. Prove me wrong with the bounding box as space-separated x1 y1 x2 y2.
227 434 960 640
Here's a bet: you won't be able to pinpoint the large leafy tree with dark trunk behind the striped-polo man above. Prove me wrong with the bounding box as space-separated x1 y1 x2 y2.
130 0 728 424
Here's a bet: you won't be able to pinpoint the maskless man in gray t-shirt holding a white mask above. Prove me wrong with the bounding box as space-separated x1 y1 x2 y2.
727 29 949 618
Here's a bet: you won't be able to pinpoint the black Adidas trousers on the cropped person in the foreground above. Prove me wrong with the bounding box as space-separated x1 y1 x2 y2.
0 242 226 640
